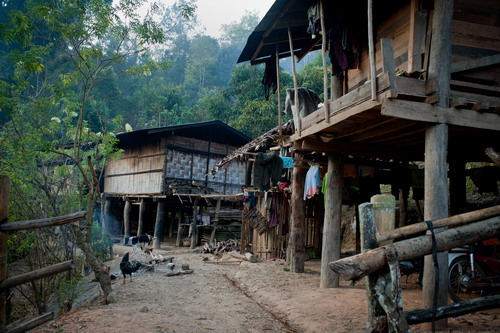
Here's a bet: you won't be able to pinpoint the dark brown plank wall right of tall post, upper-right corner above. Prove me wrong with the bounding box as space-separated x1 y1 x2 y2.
452 0 500 86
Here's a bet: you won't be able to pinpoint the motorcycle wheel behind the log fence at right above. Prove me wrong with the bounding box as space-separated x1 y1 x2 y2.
448 257 486 303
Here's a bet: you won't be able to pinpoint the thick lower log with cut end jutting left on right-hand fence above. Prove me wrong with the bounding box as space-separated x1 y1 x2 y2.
330 216 500 281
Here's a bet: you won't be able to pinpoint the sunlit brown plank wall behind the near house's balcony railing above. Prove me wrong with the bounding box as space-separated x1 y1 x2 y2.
348 2 410 91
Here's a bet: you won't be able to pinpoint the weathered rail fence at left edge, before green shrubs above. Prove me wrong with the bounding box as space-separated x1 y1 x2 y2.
0 175 87 333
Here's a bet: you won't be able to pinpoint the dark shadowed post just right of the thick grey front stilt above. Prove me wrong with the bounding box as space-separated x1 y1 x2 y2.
450 160 467 215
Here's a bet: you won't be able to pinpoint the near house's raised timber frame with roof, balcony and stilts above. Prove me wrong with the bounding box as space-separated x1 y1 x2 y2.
229 0 500 328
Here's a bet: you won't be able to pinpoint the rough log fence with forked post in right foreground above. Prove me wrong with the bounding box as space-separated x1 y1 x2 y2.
329 196 500 332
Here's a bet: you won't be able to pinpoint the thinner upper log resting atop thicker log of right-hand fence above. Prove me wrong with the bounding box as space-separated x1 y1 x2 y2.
377 205 500 243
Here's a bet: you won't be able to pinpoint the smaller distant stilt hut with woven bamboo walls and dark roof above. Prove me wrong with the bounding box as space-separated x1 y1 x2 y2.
102 120 249 248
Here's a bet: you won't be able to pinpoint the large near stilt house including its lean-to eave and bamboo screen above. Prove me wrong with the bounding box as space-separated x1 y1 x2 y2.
214 0 500 328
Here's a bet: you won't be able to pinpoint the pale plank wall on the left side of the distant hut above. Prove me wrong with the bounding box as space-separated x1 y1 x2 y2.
104 142 165 194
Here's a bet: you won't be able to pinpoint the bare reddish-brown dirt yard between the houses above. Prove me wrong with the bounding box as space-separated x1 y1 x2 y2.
35 244 500 333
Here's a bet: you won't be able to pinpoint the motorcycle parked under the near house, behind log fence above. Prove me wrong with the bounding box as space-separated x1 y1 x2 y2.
448 239 500 302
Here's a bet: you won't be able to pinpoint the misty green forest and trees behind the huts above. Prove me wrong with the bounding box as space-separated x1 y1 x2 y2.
0 0 323 321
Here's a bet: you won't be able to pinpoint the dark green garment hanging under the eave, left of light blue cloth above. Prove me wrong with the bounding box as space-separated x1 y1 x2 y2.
253 153 283 191
